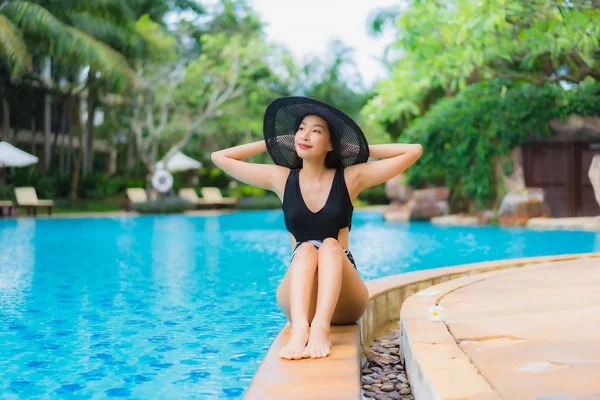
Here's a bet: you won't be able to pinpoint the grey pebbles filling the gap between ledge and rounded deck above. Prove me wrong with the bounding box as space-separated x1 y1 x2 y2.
362 331 414 400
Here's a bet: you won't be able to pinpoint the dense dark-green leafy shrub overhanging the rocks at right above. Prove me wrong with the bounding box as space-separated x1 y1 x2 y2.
399 79 600 211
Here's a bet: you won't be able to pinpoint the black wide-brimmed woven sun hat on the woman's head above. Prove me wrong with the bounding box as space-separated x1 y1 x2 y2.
263 96 369 169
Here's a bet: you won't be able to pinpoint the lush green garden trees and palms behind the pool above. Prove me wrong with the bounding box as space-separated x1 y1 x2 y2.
0 0 600 216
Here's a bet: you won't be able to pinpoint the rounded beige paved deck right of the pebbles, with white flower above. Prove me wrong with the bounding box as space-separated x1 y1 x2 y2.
400 253 600 400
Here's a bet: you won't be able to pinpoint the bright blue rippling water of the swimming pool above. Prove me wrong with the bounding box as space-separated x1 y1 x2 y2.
0 211 600 399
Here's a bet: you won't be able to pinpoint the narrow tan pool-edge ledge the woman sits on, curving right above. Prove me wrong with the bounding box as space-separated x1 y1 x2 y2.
244 252 600 400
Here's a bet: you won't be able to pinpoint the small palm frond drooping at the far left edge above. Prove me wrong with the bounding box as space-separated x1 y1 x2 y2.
0 14 31 77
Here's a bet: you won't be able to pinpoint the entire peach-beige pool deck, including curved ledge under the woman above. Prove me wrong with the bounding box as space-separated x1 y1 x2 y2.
245 253 600 400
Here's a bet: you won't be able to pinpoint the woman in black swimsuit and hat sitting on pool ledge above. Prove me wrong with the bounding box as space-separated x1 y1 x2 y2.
211 97 422 360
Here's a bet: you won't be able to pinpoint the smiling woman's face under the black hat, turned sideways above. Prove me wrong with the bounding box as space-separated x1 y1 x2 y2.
295 115 333 159
